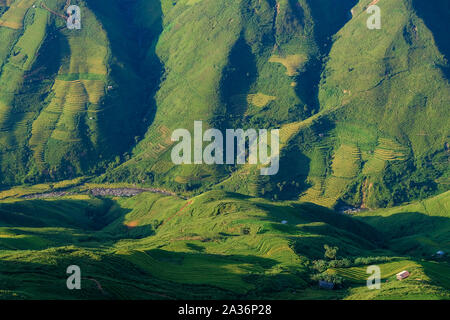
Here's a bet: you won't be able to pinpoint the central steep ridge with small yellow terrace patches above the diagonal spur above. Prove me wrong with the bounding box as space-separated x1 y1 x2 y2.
106 1 353 198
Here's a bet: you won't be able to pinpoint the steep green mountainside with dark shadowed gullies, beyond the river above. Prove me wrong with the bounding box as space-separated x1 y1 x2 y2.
0 0 450 208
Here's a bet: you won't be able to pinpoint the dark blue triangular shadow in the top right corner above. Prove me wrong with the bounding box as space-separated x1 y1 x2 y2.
413 0 450 80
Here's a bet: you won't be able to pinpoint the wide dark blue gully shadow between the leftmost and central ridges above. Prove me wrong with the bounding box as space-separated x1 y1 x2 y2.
88 0 164 159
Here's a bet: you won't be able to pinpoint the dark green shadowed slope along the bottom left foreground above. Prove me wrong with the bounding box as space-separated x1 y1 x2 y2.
0 247 316 300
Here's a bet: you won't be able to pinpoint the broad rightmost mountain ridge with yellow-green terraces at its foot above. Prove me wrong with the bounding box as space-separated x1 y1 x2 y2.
215 1 450 207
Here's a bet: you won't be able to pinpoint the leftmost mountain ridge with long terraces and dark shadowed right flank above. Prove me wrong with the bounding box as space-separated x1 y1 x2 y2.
0 0 153 184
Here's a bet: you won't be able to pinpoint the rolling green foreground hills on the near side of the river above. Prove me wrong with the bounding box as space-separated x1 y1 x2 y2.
0 191 449 299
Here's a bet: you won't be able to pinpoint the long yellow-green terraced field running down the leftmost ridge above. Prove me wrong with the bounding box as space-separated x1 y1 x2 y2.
22 3 107 163
